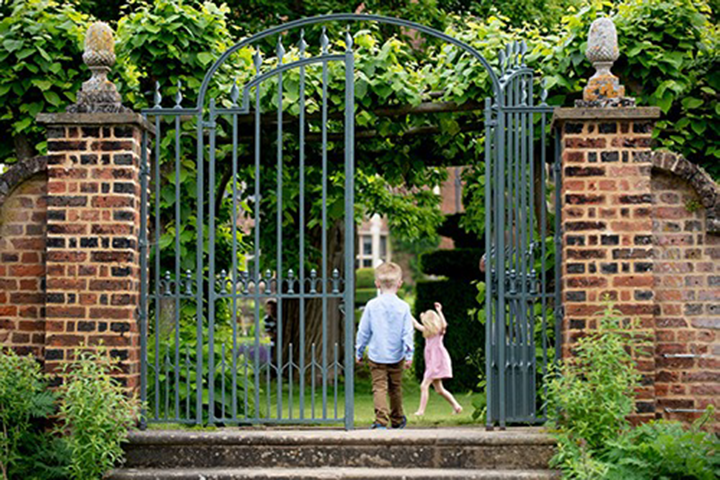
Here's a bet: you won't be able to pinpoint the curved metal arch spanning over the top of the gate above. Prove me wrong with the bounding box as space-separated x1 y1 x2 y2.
197 13 502 111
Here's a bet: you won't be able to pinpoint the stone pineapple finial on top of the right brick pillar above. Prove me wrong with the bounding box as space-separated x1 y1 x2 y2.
577 16 635 107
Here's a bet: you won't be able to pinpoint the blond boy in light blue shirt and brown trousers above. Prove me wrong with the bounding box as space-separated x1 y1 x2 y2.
355 262 414 429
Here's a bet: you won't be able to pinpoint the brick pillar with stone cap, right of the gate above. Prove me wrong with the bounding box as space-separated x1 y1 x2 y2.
555 107 659 418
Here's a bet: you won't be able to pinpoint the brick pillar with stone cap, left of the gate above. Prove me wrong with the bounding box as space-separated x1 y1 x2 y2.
38 112 149 390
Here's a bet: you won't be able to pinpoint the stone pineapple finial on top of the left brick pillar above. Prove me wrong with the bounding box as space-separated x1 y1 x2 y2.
67 22 129 113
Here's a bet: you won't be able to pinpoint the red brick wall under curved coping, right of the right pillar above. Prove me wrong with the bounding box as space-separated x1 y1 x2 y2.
652 169 720 420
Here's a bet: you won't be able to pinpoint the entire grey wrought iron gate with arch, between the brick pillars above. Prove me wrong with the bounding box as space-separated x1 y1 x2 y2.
139 14 559 428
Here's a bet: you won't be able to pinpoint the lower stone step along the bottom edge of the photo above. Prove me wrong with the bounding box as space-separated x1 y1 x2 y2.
106 468 560 480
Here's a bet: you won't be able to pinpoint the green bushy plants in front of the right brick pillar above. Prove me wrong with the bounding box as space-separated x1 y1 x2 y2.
547 306 720 480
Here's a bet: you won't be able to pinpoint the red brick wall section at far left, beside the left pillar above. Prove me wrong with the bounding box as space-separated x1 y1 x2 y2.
0 172 47 358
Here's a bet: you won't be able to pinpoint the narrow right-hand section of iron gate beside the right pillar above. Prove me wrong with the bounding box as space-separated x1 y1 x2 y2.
485 50 561 428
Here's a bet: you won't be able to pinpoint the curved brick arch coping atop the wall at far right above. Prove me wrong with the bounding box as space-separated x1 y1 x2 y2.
652 151 720 234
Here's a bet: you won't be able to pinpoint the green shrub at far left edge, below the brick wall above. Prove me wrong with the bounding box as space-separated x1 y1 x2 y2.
0 350 54 480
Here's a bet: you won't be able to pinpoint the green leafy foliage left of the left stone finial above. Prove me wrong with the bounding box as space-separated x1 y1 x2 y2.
0 0 88 163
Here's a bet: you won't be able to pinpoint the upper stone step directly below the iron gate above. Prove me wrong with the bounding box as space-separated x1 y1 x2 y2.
125 428 554 468
